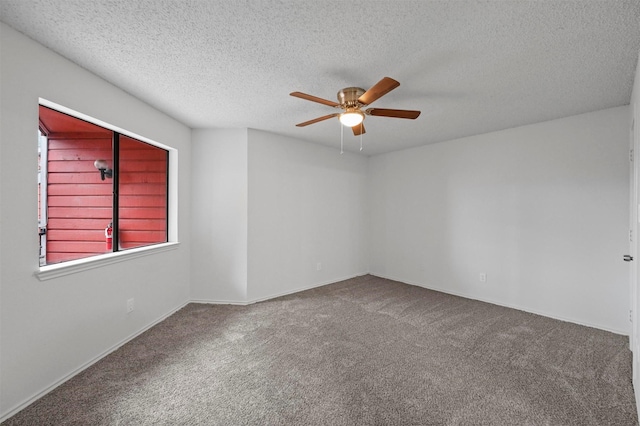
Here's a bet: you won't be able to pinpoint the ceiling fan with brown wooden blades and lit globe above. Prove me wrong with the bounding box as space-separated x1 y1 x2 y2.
290 77 420 136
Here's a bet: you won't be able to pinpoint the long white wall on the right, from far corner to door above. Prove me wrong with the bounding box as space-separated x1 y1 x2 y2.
369 107 630 334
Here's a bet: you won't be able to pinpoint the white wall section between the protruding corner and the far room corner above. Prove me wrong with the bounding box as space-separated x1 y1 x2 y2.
248 130 369 300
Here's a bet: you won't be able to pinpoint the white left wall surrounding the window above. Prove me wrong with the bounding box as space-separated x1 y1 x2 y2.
0 23 190 419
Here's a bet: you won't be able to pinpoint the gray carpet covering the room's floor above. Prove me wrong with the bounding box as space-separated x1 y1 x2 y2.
3 276 638 426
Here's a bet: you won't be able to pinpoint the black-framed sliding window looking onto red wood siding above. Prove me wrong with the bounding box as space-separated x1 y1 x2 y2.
38 105 169 266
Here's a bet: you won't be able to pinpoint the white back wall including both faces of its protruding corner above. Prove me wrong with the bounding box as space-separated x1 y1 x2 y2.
191 129 368 303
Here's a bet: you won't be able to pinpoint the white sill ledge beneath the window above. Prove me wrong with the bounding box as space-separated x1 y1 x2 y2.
34 242 180 281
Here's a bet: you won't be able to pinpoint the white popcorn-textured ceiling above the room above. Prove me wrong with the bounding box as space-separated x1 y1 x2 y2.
0 0 640 155
